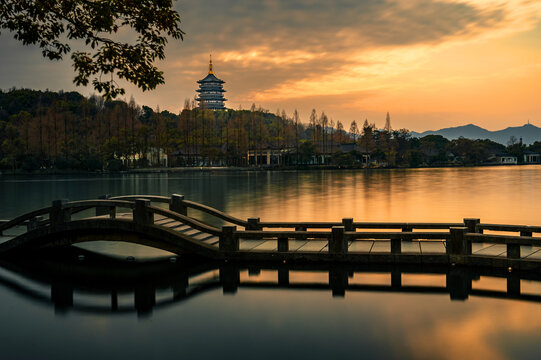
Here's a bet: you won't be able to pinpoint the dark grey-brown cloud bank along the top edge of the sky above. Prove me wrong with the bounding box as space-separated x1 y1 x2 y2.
178 0 507 52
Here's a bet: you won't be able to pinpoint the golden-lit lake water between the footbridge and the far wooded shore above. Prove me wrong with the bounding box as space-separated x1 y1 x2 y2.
0 165 541 225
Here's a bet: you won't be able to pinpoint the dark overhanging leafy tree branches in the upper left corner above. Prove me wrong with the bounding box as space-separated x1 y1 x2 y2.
0 0 183 99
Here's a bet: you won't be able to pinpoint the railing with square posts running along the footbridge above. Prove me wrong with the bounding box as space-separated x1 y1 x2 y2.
0 194 541 267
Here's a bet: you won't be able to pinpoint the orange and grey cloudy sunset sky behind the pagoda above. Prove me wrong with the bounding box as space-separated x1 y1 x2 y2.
0 0 541 131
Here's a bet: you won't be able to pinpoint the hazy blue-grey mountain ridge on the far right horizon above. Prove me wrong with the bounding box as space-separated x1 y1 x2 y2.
411 124 541 145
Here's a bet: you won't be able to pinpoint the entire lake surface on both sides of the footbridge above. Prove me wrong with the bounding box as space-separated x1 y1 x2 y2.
0 166 541 359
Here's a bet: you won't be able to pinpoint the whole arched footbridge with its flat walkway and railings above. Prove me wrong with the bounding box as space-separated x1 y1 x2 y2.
0 195 541 271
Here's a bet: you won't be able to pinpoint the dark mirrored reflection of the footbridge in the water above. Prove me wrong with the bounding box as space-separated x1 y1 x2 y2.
0 248 541 316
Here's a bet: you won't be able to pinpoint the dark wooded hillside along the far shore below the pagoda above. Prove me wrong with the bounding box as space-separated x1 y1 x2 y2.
0 89 541 172
